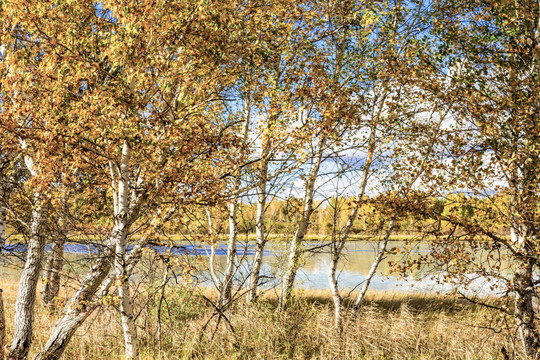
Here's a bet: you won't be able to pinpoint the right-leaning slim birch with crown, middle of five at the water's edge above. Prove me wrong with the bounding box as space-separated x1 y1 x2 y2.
280 1 382 308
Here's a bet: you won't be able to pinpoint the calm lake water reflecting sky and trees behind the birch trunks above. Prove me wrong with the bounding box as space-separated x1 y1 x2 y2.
2 241 500 295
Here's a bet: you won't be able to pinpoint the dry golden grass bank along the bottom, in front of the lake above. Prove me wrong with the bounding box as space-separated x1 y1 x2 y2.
2 282 519 360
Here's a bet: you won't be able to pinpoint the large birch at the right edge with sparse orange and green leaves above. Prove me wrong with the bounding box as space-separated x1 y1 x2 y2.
408 1 540 359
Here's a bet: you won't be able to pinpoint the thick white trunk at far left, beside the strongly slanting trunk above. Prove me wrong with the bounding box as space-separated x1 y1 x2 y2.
8 193 45 360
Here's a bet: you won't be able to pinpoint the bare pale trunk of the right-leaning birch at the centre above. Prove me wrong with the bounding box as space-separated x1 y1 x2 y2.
278 137 326 310
